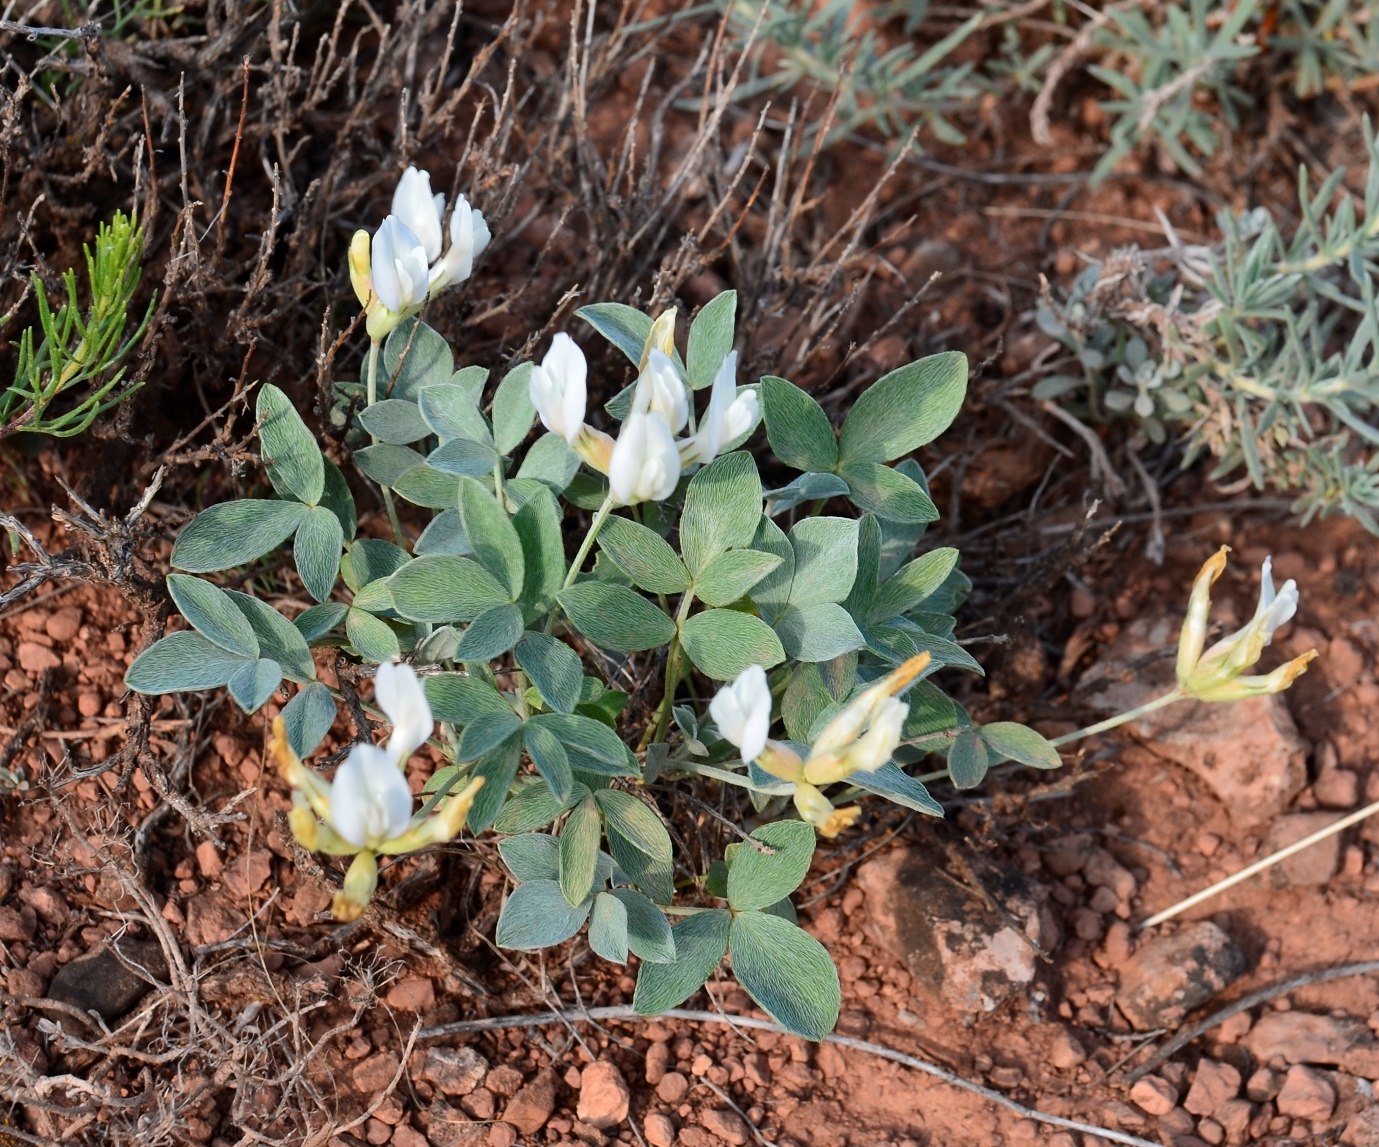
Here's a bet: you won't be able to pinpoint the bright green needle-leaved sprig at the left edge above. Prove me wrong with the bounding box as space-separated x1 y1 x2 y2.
0 211 157 438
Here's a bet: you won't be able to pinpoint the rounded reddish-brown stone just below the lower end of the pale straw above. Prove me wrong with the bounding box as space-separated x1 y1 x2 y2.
1116 921 1249 1031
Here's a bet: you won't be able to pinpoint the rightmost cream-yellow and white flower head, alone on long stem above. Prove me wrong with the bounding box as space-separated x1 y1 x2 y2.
1178 546 1317 702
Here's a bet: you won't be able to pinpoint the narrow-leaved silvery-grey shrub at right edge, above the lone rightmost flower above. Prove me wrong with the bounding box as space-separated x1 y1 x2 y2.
1034 121 1379 532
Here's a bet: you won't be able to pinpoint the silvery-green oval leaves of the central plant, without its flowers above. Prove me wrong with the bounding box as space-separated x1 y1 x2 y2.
125 292 1037 1038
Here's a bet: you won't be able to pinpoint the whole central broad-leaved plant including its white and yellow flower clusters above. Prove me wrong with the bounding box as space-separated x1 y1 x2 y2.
125 168 1318 1038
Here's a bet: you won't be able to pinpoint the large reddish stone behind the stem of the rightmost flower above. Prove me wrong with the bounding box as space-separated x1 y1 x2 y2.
1080 615 1307 829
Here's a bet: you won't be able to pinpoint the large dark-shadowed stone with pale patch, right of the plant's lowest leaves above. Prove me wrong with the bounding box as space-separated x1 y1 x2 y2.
858 848 1058 1012
